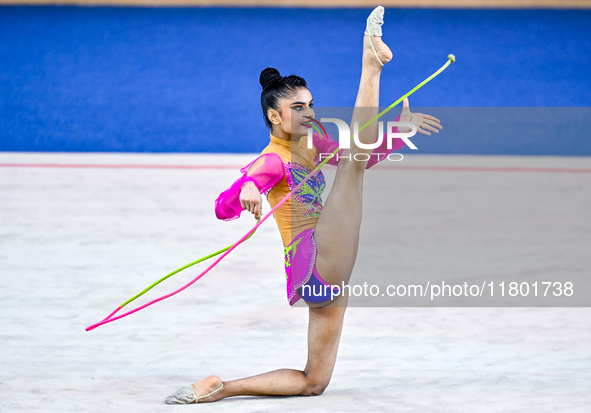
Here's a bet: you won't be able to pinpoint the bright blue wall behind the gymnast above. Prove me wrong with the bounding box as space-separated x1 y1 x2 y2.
0 6 591 156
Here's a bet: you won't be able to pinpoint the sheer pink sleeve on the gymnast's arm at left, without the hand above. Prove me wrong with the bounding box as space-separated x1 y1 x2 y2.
215 153 285 221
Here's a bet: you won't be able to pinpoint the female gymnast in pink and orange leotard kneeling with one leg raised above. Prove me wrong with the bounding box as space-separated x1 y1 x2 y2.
166 6 441 404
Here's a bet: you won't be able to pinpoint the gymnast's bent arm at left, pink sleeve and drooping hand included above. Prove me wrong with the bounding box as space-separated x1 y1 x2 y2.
215 153 285 221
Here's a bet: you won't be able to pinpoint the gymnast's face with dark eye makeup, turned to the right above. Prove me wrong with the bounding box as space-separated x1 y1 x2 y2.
269 87 315 140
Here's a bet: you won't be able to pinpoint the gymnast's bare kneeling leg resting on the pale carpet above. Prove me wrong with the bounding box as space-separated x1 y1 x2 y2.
193 297 347 403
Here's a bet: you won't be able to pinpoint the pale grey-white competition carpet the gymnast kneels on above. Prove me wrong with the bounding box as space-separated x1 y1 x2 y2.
0 153 591 413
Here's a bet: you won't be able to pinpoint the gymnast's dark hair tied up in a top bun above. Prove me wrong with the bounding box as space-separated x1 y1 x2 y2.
259 67 308 129
